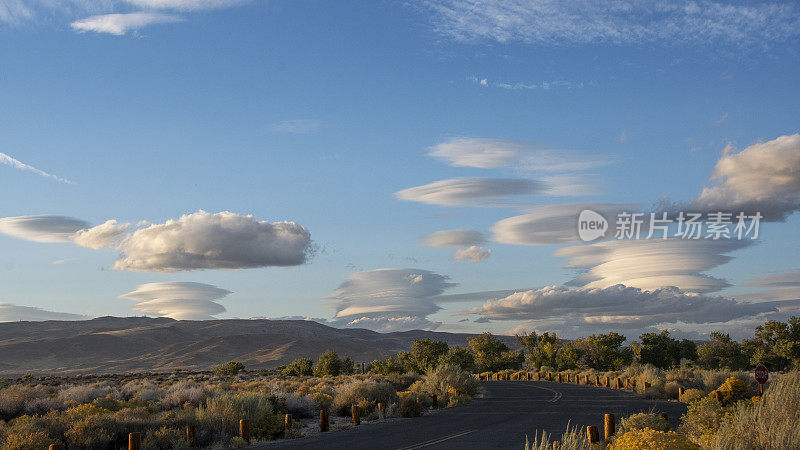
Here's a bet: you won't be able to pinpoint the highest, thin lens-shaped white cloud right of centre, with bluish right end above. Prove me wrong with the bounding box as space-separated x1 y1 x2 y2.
428 138 608 171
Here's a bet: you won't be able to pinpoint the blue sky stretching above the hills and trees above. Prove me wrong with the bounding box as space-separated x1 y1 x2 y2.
0 0 800 336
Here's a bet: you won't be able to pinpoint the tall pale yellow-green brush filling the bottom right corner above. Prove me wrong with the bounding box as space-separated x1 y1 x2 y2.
713 372 800 450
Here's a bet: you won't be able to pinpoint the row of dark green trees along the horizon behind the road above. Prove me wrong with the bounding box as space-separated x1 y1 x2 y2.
356 317 800 375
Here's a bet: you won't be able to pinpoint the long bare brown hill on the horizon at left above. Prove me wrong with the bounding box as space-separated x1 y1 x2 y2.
0 317 518 376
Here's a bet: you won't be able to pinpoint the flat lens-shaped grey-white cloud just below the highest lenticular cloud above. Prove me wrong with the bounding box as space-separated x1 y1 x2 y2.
395 178 549 206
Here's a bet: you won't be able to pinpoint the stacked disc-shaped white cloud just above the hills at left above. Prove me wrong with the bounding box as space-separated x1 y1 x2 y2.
119 282 231 320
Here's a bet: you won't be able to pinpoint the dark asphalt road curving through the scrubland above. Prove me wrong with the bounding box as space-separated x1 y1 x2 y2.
253 381 686 450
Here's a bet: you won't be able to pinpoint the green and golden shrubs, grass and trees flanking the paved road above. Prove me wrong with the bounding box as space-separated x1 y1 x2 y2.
0 317 800 450
